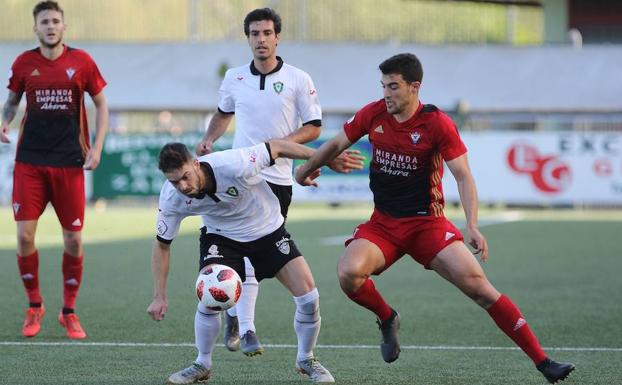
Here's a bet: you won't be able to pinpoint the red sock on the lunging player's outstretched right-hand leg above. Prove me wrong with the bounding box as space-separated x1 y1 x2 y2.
488 295 546 365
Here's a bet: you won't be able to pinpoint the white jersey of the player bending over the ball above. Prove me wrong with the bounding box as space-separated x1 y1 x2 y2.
156 143 284 242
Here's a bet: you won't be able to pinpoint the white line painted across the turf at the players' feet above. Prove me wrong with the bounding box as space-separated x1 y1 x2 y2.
0 341 622 352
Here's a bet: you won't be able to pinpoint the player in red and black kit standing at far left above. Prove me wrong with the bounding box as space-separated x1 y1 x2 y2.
0 1 108 339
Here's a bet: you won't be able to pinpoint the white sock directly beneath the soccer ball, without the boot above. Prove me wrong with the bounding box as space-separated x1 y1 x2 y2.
194 303 220 369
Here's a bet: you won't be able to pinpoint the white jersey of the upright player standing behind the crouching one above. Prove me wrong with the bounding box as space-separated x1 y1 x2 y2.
218 58 322 185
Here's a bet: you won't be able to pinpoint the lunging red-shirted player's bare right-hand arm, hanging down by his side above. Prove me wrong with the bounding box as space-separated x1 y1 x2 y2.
447 154 488 262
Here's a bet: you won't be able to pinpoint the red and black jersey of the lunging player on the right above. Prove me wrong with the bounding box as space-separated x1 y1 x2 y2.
344 99 467 218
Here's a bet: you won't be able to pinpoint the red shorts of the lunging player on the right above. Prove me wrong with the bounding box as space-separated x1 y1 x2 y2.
346 210 464 268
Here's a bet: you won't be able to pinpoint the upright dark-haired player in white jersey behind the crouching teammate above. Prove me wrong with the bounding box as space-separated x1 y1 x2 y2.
196 8 362 356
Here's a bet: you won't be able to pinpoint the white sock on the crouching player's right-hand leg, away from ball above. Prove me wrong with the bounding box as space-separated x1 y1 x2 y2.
294 288 322 361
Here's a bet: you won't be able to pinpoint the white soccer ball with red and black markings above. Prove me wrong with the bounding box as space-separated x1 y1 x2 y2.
196 265 242 310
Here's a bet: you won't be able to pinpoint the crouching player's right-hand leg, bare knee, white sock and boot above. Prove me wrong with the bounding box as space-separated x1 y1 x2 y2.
276 256 335 383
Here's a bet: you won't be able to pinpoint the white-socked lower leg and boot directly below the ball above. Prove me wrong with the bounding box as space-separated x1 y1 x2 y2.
168 304 220 384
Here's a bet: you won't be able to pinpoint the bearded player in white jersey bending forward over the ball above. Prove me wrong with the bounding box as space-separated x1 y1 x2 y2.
147 139 335 384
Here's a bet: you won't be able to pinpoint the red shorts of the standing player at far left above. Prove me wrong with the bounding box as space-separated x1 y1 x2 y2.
13 162 86 231
